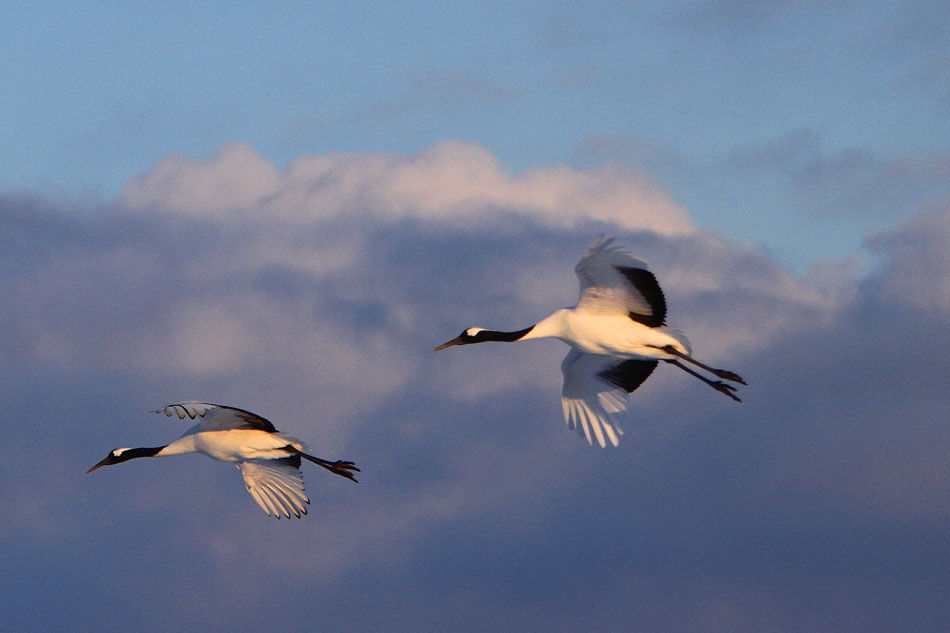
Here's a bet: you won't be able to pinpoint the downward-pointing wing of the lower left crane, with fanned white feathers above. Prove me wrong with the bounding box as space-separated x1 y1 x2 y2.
235 455 310 519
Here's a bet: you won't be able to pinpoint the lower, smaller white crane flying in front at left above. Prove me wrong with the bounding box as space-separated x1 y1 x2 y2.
86 402 360 519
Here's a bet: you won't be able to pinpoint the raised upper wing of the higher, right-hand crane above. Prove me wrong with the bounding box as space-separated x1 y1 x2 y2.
574 235 666 327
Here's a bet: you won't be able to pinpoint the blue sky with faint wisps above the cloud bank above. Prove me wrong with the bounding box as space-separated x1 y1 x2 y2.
0 0 950 270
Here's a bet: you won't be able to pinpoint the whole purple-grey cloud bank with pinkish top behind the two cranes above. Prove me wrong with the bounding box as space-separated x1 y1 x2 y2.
0 143 950 632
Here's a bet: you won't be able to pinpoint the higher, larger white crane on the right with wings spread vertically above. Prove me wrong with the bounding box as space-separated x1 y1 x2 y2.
435 235 746 446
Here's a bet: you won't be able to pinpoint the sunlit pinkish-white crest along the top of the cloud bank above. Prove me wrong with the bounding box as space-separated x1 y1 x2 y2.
121 141 694 235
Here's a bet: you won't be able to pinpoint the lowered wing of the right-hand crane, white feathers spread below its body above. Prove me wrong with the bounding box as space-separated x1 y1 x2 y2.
561 349 657 447
